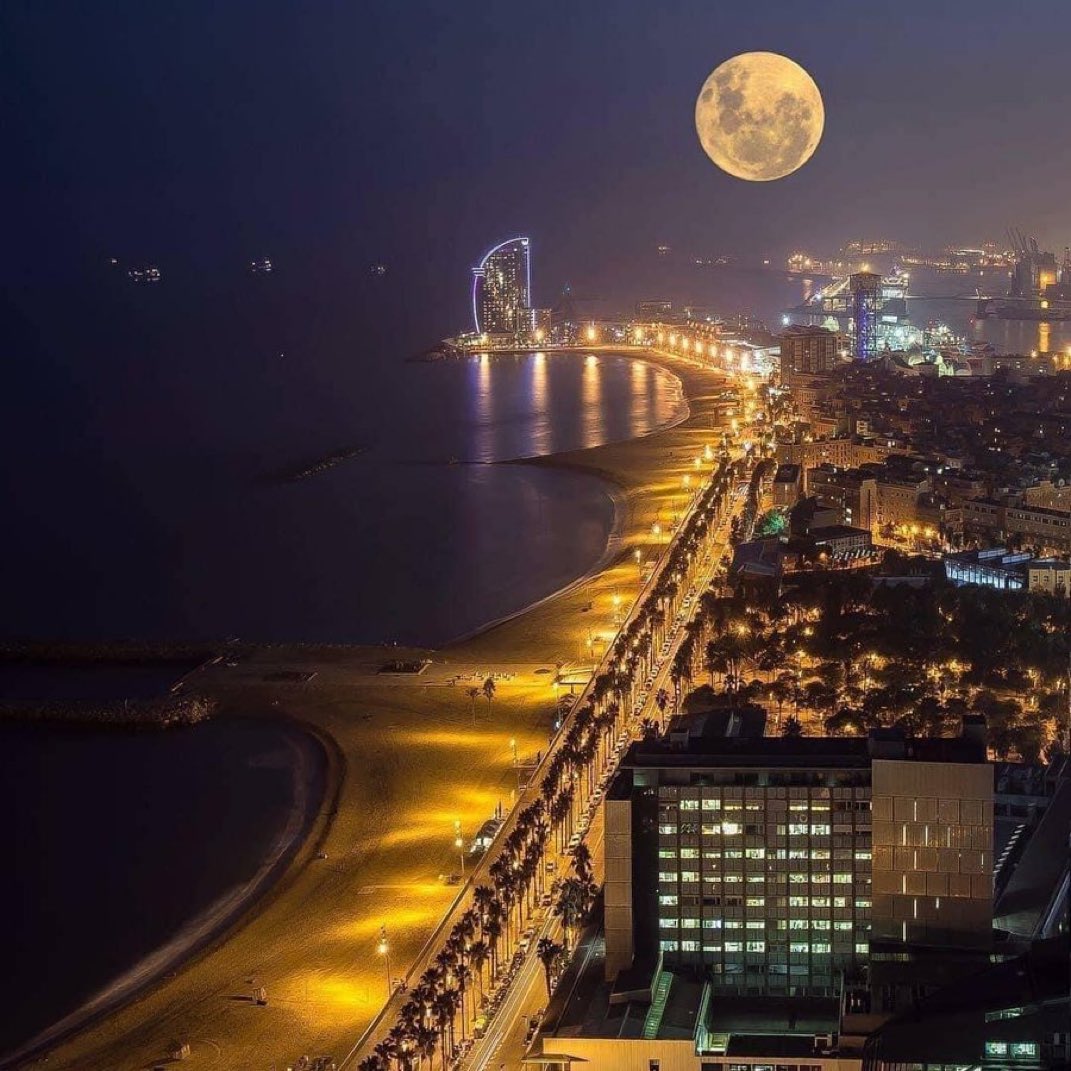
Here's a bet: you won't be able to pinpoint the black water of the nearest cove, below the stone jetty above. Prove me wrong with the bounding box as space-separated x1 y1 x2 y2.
0 721 323 1056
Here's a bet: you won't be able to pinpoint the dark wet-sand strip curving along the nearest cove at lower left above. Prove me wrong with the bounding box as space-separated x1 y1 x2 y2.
0 715 334 1071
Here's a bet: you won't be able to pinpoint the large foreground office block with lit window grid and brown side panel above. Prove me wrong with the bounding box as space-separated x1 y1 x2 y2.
605 711 993 998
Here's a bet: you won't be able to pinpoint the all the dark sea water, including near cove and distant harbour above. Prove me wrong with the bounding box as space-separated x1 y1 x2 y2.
0 254 1058 1053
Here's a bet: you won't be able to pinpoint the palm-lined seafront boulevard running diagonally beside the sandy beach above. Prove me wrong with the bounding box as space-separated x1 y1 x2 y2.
343 398 751 1071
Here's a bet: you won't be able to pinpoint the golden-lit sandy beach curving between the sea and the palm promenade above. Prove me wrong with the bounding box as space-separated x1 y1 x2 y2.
37 353 724 1071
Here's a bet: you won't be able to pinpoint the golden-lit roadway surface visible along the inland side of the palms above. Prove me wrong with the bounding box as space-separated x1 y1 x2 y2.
461 483 748 1071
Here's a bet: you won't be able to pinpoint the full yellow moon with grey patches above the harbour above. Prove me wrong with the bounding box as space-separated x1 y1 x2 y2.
695 52 826 182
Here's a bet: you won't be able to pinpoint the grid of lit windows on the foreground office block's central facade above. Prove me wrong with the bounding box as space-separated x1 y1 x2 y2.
657 779 871 996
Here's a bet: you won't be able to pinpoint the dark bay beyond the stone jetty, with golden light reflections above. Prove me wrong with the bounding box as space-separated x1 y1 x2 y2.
0 275 684 645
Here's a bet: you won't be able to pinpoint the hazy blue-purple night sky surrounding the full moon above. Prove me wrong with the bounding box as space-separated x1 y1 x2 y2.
6 0 1071 297
